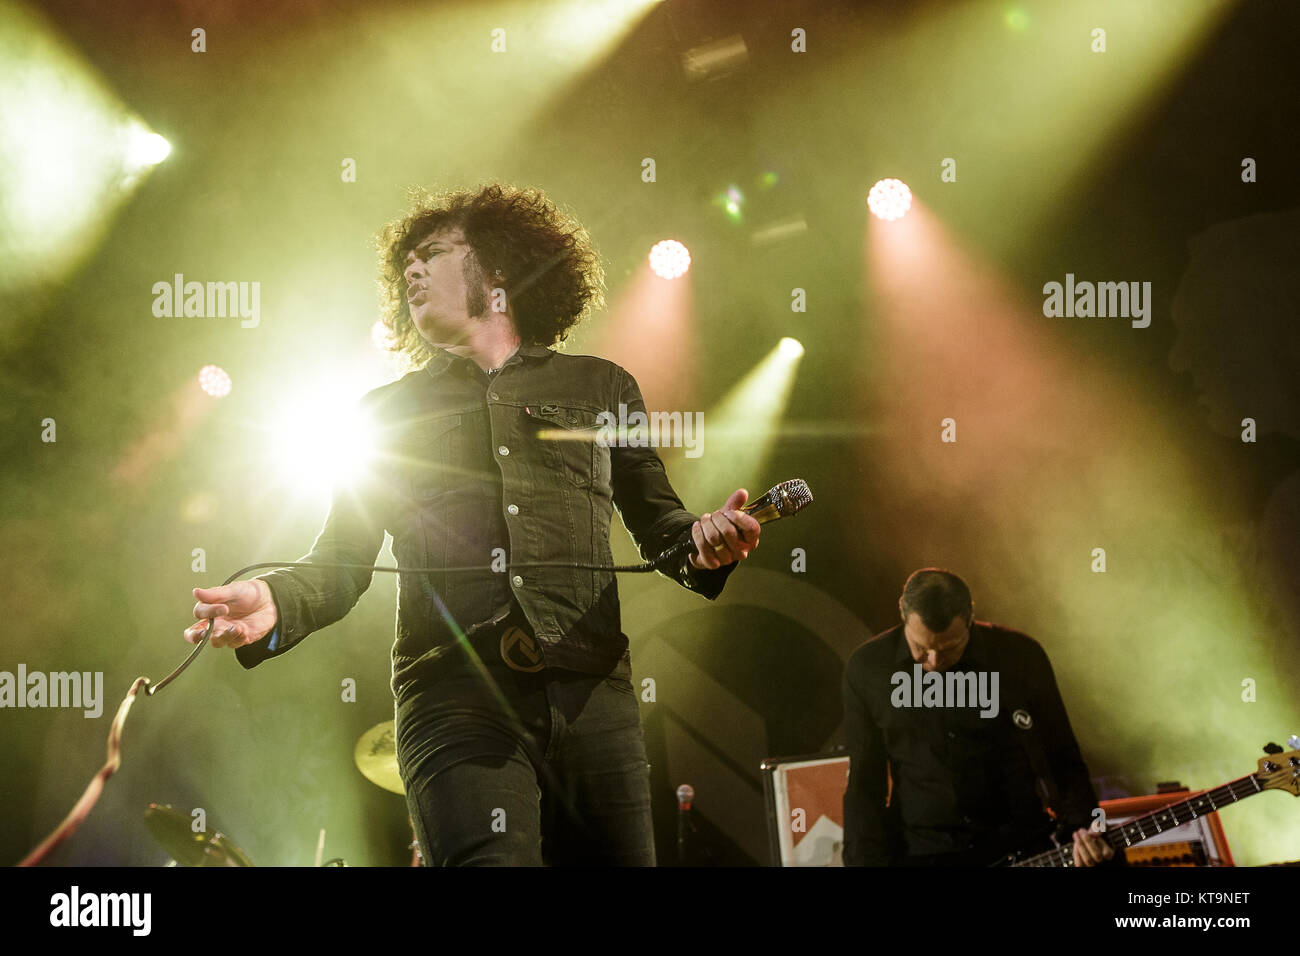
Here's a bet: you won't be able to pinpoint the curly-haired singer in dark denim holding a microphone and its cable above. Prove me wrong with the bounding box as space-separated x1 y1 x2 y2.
185 185 759 865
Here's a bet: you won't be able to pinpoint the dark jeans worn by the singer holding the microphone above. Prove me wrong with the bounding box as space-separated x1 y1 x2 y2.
397 637 655 866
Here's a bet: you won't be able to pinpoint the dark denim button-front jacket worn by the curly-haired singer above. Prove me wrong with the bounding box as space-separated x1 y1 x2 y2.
238 345 736 696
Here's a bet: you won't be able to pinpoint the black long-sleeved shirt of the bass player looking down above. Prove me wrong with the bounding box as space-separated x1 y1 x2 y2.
842 622 1096 866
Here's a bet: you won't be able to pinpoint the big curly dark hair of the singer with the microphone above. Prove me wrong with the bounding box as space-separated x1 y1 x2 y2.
376 183 605 365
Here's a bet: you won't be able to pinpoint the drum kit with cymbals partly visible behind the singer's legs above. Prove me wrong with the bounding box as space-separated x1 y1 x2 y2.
144 721 424 866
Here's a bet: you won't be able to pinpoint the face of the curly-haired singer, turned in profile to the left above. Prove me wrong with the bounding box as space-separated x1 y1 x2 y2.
403 228 490 349
